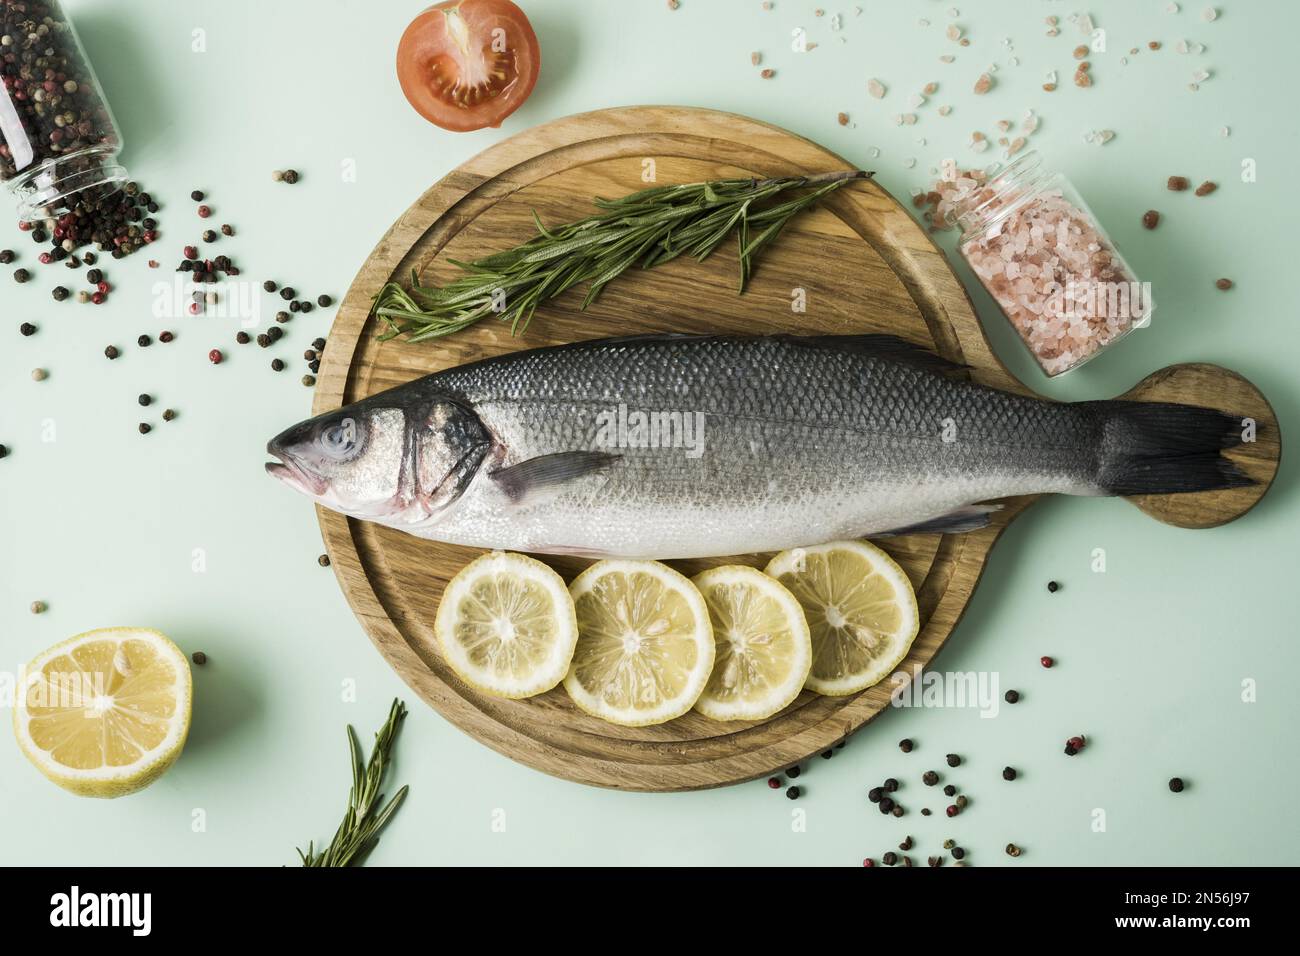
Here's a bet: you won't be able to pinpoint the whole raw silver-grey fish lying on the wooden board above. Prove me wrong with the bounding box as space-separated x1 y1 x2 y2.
267 333 1252 559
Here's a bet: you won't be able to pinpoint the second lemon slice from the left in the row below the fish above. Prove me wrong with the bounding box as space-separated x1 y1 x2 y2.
564 561 714 727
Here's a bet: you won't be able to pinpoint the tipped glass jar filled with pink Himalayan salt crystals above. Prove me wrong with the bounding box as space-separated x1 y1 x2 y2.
943 151 1154 376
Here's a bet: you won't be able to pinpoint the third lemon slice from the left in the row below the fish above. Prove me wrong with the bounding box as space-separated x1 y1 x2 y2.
690 564 813 721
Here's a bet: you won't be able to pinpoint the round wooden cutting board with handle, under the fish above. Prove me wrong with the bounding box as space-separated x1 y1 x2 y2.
315 107 1279 791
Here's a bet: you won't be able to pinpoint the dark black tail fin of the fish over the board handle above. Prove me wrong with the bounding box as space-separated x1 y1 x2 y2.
1082 401 1255 494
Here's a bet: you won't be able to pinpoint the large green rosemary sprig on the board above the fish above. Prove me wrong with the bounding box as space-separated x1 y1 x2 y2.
371 169 872 342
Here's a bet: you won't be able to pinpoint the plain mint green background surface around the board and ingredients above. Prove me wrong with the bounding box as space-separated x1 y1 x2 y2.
0 0 1300 866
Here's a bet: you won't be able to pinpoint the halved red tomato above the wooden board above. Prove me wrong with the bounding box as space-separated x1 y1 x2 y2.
397 0 542 133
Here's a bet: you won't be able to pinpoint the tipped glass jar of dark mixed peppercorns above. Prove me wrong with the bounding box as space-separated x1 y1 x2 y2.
0 0 127 221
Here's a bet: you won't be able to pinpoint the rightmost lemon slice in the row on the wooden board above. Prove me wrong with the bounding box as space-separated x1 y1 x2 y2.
767 541 919 697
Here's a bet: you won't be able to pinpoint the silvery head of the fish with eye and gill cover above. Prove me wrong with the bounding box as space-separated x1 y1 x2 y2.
267 395 491 528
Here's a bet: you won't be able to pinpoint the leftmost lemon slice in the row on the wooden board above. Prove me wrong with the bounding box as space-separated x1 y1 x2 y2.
434 551 577 698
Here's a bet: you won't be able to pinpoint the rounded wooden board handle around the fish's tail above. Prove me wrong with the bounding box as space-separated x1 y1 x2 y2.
1119 363 1282 528
